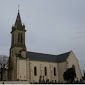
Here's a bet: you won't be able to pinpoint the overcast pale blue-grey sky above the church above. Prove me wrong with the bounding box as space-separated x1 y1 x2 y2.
0 0 85 73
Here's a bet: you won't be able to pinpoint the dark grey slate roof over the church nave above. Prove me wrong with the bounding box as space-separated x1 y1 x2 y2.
27 51 70 62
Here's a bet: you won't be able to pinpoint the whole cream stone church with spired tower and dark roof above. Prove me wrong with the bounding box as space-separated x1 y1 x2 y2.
9 10 82 83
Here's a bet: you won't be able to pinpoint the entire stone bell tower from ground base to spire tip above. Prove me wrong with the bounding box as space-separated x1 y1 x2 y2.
9 10 27 80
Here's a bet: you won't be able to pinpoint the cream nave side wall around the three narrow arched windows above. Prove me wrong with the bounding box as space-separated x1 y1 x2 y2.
29 61 58 83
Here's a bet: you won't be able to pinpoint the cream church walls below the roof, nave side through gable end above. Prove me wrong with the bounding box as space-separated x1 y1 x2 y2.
30 51 82 83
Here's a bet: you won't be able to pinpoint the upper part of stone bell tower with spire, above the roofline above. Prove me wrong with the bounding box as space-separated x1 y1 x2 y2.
10 10 26 56
